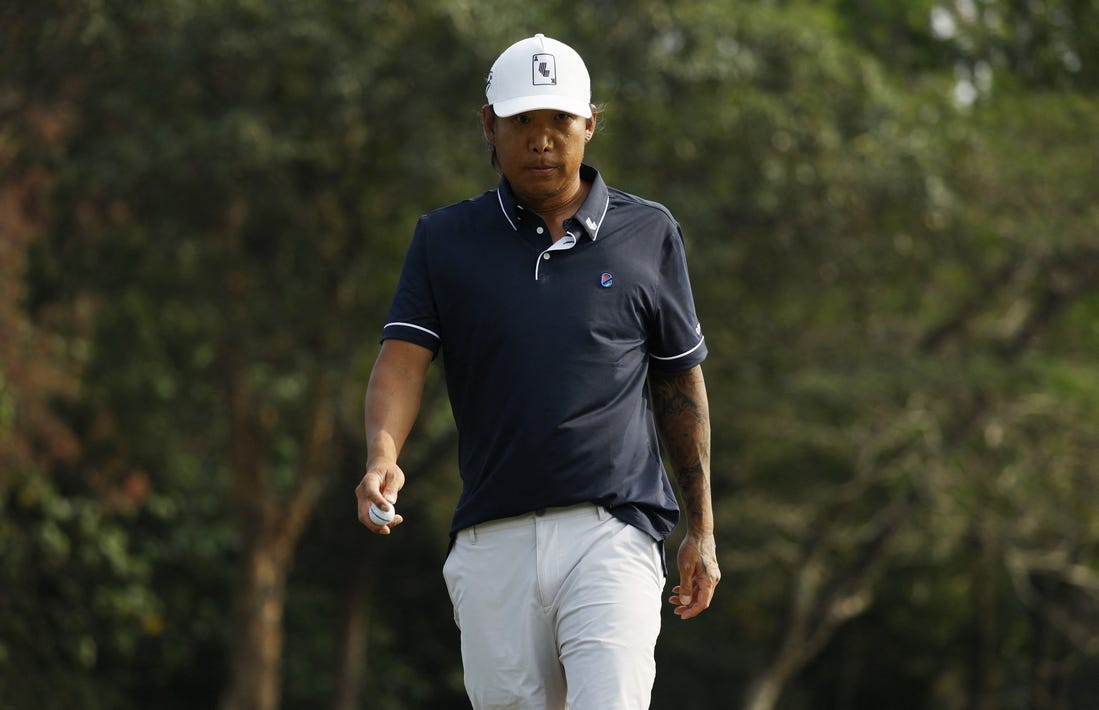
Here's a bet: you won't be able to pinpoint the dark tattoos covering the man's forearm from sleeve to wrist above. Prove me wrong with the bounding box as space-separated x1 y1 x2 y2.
650 367 710 520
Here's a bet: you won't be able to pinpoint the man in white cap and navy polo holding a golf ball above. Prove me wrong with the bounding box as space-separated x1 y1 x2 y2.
356 34 720 710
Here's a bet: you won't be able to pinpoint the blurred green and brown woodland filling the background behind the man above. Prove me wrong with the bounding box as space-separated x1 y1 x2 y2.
0 0 1099 710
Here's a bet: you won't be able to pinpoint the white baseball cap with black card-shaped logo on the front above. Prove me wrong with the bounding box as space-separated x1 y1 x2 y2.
485 34 591 119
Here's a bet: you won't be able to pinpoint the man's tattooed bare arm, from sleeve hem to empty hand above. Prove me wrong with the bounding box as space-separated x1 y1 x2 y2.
648 366 721 619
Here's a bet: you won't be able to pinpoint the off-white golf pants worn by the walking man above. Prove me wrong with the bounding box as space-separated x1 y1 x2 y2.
443 504 664 710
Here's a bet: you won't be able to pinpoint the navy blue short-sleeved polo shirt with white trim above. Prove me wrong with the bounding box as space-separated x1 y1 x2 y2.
382 166 707 540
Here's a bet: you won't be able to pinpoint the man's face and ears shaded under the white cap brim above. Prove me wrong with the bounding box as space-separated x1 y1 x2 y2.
481 107 596 208
